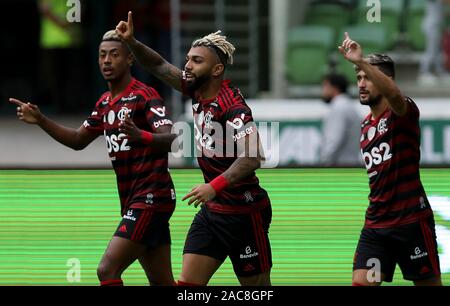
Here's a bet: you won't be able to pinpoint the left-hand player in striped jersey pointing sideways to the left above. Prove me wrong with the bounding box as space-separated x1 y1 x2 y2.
10 31 176 286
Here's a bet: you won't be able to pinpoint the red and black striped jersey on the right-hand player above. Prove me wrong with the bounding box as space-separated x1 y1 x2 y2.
361 97 432 228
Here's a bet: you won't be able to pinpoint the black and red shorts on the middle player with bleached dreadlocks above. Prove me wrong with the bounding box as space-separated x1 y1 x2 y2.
183 205 272 277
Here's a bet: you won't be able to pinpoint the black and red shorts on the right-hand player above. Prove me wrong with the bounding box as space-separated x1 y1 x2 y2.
353 216 441 282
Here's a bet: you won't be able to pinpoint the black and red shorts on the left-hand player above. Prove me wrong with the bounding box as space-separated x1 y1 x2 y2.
114 208 173 249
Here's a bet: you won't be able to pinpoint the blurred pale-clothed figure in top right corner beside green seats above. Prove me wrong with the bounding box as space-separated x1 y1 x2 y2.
418 0 450 85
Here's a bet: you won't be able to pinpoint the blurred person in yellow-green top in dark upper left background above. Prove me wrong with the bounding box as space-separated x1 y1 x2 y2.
39 0 85 111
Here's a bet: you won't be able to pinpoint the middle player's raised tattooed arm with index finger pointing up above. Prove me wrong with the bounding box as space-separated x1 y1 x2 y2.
116 12 183 91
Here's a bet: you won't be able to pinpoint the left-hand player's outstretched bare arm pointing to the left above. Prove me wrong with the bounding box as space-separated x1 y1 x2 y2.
9 98 98 151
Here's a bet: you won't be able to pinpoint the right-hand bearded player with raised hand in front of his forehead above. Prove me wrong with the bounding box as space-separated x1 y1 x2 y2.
339 33 442 286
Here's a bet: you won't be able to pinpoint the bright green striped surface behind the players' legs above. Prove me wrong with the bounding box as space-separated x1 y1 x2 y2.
0 169 450 285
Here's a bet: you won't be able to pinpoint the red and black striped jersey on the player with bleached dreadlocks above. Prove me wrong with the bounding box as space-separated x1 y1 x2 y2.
183 81 270 214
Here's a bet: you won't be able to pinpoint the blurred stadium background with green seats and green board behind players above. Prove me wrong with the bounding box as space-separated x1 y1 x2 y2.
0 0 450 285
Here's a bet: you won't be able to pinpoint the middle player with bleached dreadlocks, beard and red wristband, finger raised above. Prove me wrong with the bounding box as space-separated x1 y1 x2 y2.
116 12 272 285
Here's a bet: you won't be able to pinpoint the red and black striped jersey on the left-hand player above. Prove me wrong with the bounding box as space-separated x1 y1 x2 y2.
84 79 176 214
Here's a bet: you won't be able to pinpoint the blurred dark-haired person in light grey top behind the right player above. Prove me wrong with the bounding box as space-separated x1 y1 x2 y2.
320 74 363 166
